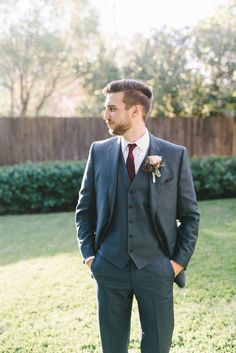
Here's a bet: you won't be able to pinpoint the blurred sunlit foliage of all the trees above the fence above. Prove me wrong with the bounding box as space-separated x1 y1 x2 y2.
0 0 236 118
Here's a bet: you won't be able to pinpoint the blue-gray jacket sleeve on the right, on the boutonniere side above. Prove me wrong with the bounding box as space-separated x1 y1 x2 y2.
173 148 200 268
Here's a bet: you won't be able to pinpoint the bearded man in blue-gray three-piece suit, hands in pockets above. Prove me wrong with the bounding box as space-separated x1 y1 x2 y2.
76 79 199 353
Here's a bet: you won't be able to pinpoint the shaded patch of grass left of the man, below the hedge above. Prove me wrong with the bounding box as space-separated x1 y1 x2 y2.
0 212 78 265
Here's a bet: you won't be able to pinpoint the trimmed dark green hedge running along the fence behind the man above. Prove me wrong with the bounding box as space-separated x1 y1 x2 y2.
0 157 236 214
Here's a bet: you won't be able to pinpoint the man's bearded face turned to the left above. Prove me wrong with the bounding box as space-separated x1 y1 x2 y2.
103 92 132 135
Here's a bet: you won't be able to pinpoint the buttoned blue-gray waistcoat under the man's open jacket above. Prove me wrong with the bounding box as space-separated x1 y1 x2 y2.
98 147 163 269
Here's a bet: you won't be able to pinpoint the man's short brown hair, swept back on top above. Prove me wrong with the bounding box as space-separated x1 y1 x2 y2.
102 79 152 121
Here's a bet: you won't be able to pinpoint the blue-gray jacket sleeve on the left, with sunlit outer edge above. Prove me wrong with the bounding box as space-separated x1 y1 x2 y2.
75 144 96 259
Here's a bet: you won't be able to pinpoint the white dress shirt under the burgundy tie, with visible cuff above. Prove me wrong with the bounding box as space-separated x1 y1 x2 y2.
84 128 150 263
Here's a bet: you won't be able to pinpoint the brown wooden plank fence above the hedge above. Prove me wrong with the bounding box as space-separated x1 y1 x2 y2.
0 117 236 165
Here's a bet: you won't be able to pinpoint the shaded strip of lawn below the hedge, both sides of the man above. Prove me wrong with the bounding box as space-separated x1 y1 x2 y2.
0 199 236 265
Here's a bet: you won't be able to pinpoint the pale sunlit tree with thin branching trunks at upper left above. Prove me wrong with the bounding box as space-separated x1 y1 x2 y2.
0 0 98 117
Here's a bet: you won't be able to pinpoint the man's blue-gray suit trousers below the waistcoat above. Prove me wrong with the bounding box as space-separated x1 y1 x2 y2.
91 254 174 353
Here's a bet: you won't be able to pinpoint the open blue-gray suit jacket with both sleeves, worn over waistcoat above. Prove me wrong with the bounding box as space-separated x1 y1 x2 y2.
76 134 200 286
